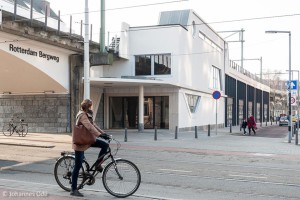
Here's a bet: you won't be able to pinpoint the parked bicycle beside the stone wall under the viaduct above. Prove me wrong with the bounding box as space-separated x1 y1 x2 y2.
2 118 28 137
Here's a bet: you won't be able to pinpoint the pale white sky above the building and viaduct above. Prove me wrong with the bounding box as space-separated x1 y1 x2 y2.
49 0 300 79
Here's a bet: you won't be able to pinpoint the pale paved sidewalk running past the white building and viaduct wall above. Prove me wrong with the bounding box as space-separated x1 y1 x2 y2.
0 123 300 155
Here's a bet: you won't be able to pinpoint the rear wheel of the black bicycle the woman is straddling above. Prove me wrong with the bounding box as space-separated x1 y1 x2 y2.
54 155 85 192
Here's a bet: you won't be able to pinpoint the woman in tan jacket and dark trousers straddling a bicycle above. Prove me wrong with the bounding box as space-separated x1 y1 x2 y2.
70 99 108 197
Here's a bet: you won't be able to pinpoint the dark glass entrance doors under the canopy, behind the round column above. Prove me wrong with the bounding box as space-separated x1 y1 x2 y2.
109 97 169 129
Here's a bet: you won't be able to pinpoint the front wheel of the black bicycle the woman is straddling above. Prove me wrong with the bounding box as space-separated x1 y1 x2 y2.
102 159 141 198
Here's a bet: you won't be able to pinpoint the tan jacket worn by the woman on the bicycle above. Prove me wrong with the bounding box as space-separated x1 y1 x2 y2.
72 111 104 151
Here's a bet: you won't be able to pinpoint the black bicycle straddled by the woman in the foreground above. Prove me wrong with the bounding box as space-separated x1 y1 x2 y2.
54 137 141 198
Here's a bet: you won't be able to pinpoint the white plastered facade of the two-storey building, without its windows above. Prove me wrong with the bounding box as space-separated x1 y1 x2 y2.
91 10 228 130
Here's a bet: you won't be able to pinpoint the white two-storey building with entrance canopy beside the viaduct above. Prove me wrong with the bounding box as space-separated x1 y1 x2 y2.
91 10 229 130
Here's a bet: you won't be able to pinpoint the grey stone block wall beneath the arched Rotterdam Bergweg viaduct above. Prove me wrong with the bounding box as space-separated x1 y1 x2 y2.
0 94 70 133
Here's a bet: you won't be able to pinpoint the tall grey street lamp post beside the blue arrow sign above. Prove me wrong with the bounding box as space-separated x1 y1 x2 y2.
265 31 292 143
